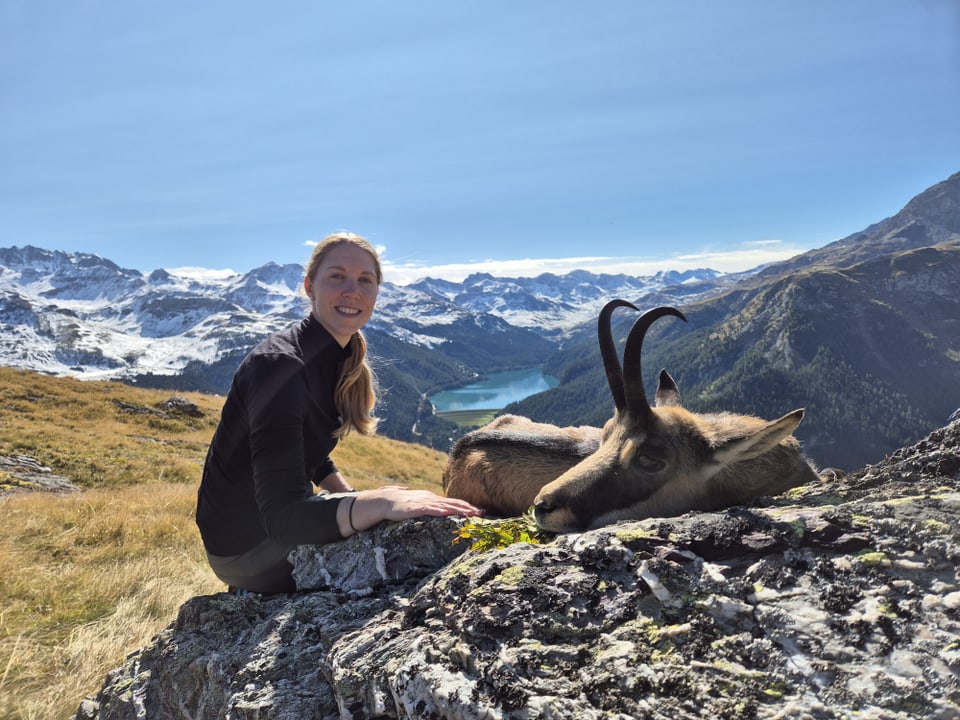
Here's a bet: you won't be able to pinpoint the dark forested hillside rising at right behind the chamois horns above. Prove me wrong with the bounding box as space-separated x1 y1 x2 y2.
505 174 960 469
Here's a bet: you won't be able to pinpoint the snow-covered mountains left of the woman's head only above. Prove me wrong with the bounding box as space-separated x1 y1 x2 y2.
0 247 302 379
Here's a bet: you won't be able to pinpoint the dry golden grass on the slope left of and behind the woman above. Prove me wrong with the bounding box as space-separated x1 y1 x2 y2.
0 368 445 720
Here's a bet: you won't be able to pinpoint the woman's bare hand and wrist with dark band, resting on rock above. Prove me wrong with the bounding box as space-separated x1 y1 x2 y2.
337 485 484 537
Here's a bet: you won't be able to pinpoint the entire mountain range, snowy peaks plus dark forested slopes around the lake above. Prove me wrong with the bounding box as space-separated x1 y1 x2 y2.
0 173 960 468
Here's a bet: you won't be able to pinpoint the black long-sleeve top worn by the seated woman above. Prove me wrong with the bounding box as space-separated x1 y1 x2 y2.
196 315 350 556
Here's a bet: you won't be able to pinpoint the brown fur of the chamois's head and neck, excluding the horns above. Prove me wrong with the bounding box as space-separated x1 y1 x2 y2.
534 407 818 532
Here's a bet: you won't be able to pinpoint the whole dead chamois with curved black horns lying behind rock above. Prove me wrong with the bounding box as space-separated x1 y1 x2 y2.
444 300 819 532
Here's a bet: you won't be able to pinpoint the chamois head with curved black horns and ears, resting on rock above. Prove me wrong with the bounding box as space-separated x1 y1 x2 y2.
534 300 818 532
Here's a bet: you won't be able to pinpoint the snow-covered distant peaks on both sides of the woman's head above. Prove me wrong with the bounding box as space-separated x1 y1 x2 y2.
0 247 718 389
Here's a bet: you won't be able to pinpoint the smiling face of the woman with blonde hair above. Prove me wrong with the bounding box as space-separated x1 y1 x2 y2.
303 243 380 347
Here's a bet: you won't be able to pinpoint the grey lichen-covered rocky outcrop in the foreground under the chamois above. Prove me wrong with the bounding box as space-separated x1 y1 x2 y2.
77 422 960 720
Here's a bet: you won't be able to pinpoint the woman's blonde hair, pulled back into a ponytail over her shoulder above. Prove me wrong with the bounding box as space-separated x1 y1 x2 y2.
306 232 383 438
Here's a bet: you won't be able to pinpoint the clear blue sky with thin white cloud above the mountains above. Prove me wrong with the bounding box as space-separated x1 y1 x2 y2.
0 0 960 282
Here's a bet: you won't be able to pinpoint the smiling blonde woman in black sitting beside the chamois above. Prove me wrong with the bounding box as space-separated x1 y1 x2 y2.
197 233 481 593
